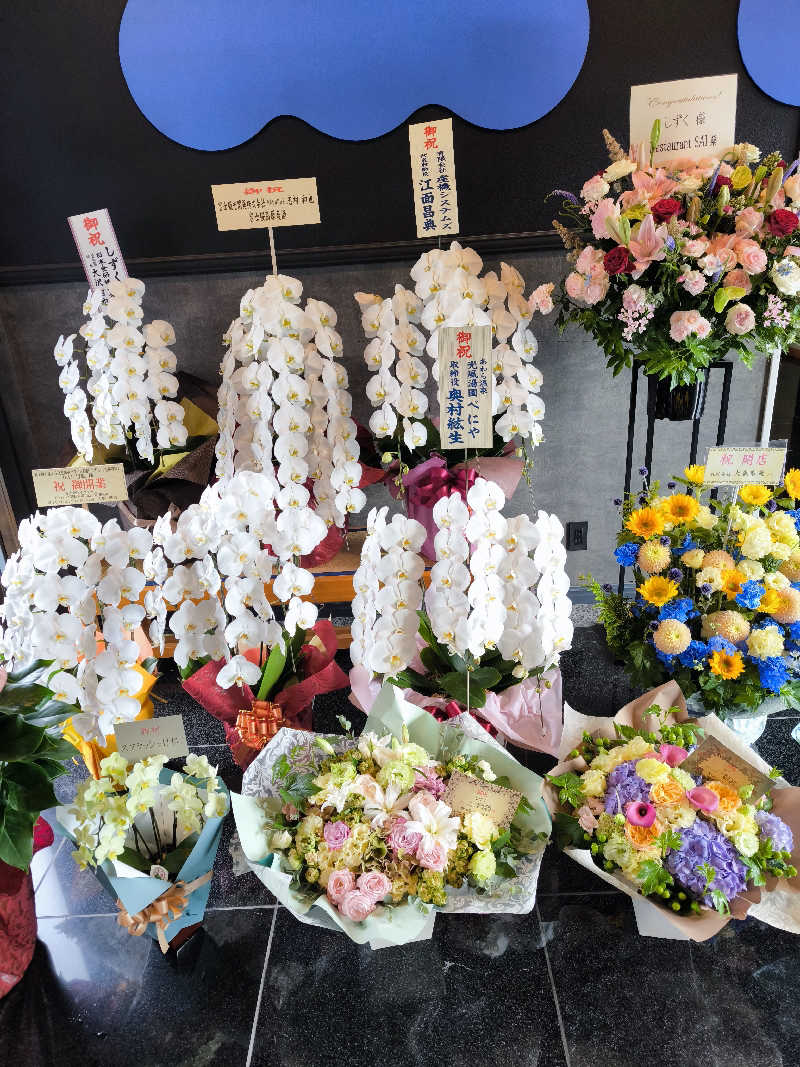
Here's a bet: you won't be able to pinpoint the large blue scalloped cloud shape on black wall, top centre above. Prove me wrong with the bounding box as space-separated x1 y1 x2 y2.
119 0 589 152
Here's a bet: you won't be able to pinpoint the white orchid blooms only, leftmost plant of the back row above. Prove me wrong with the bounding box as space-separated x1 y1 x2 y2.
53 277 188 466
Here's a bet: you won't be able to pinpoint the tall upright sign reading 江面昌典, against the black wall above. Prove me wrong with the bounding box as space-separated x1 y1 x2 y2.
409 118 459 237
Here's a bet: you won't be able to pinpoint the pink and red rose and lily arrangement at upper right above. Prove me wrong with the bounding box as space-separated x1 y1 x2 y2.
551 122 800 386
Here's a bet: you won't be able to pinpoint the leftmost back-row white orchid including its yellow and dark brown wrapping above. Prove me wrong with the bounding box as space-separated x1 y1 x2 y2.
53 277 217 525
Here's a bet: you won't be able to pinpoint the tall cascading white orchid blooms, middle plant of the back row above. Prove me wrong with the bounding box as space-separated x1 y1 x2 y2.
217 274 366 527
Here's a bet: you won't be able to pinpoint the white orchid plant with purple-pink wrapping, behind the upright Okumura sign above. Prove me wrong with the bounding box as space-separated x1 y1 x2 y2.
355 241 553 556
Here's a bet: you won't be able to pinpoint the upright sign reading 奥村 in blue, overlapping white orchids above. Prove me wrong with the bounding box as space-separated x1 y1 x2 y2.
438 325 494 448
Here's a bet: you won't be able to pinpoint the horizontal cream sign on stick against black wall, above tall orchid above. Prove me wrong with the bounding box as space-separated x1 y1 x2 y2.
211 178 320 229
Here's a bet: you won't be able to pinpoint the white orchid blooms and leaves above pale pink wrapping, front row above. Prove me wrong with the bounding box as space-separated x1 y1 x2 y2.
350 478 573 708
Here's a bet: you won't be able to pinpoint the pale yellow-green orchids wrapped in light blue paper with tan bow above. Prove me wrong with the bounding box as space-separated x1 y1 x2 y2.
57 752 228 952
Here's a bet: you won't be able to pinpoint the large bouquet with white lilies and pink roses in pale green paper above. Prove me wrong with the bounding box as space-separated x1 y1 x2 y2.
233 685 550 947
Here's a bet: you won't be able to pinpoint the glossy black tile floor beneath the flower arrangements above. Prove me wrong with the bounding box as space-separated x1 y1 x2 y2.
0 626 800 1067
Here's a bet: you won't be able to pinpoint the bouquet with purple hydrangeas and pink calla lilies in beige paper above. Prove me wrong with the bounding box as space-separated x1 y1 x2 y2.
545 682 800 941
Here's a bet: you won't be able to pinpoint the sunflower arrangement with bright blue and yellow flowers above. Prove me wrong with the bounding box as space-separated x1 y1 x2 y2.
590 466 800 718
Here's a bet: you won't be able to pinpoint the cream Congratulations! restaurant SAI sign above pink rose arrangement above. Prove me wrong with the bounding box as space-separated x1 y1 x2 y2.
630 74 737 163
